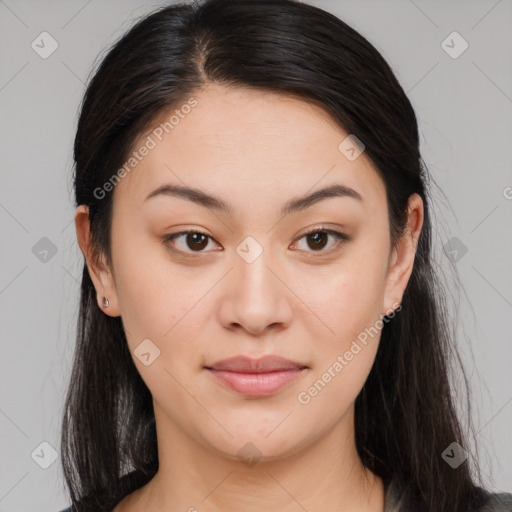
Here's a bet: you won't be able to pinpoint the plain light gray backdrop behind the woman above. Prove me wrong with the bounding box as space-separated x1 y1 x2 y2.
0 0 512 512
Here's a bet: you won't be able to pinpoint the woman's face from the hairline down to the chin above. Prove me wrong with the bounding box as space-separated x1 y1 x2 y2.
77 86 422 460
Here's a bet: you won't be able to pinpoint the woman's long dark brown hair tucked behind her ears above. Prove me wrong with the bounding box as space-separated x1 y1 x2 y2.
62 0 492 512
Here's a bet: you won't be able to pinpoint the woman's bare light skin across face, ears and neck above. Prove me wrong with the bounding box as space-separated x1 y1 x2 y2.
75 85 423 512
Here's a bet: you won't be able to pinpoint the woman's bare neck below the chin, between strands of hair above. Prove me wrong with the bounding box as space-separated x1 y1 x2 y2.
122 403 385 512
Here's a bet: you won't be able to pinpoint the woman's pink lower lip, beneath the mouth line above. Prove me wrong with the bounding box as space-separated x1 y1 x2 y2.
209 368 304 397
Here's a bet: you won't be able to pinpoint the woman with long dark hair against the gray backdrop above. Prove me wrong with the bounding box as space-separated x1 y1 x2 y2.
62 0 512 512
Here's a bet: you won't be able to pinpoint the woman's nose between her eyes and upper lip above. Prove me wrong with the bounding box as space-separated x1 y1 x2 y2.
218 247 293 336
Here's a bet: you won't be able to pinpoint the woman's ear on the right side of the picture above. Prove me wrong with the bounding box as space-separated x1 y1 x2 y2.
382 194 424 315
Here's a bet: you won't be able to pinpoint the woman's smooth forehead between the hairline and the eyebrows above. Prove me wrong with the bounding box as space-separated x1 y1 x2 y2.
115 85 383 210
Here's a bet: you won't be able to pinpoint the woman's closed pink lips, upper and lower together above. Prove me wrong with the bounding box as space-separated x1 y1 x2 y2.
205 356 308 397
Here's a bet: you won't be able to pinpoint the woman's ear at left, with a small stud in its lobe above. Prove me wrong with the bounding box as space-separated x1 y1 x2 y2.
75 204 120 317
